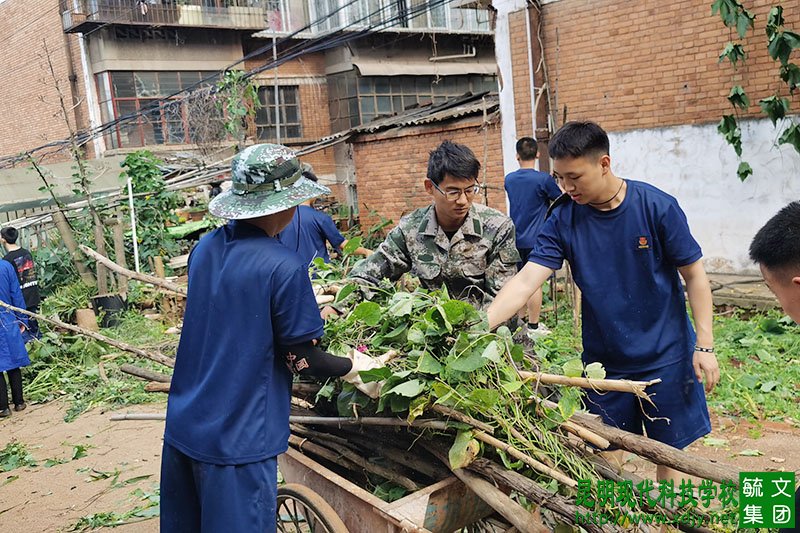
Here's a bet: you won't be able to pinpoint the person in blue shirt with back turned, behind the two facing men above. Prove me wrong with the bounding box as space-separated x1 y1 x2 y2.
504 137 561 337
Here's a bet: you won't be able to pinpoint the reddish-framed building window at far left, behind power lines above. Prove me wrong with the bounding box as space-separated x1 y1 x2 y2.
96 71 223 148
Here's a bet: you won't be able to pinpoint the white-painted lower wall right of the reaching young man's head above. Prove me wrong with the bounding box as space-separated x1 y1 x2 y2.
608 117 800 273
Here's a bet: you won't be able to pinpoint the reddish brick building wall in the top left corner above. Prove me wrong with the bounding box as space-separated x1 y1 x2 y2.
0 0 88 161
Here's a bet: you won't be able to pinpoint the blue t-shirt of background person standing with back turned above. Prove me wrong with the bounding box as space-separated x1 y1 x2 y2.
505 168 561 249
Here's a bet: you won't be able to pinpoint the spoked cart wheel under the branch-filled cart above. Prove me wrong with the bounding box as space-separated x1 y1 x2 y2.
277 483 349 533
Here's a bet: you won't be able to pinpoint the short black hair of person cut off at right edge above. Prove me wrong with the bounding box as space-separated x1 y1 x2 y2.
750 202 800 270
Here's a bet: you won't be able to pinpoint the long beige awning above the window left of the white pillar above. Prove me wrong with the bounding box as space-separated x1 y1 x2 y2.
352 56 497 76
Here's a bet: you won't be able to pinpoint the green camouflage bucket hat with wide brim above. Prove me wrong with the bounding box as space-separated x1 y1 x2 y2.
208 144 331 220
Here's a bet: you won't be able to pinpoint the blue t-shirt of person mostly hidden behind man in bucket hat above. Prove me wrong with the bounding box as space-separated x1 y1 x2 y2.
278 205 344 265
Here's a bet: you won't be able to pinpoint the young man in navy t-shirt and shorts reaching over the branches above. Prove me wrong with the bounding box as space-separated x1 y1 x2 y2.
487 122 719 481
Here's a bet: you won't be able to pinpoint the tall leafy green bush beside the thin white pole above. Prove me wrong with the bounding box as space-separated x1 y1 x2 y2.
122 150 182 262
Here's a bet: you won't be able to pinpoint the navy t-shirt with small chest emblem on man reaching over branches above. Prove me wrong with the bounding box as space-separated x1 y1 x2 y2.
528 180 702 372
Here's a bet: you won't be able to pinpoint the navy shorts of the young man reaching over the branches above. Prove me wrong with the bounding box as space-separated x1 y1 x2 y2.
586 359 711 449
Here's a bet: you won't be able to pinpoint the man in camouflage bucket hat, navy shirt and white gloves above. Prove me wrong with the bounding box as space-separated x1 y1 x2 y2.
161 144 383 533
